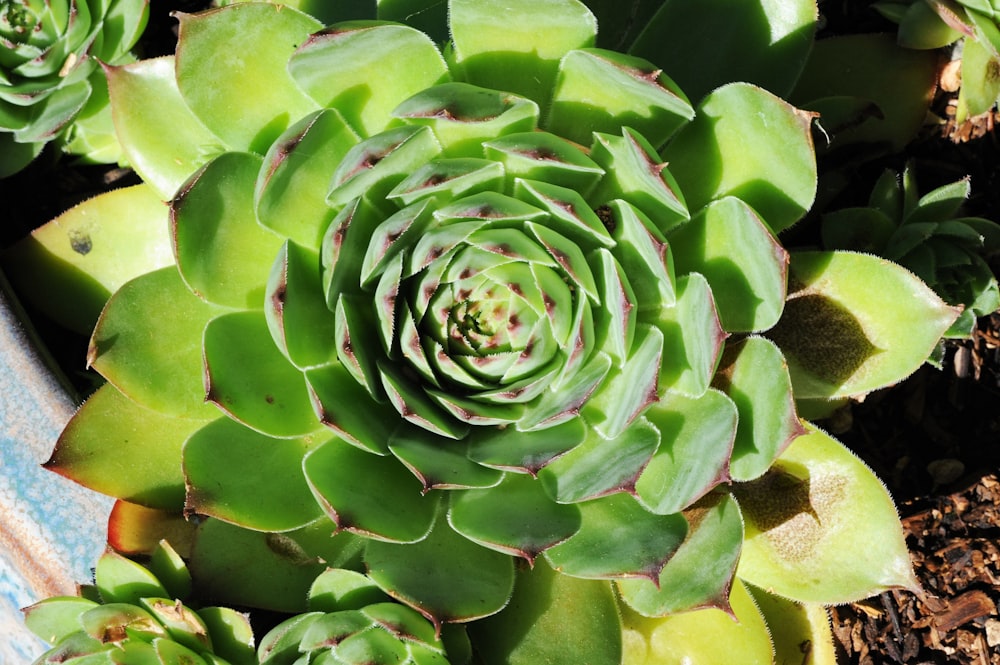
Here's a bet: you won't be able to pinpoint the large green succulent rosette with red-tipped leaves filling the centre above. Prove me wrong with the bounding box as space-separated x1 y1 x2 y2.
1 0 958 663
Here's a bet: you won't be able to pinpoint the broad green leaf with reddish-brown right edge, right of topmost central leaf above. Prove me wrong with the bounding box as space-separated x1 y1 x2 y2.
543 49 694 145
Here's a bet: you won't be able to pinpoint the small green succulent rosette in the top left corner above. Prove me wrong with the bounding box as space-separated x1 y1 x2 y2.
0 0 149 177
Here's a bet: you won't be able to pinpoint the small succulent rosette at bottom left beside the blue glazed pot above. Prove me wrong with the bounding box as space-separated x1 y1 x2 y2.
24 541 256 665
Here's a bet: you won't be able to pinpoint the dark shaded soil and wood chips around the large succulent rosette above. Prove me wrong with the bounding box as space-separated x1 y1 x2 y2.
0 0 1000 665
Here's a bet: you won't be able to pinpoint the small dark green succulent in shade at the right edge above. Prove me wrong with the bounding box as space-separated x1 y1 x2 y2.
822 165 1000 338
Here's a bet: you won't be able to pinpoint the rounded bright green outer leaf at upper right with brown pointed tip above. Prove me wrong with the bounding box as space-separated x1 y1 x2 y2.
663 83 816 233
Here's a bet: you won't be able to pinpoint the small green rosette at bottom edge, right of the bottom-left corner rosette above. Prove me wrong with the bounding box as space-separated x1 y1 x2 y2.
257 568 462 665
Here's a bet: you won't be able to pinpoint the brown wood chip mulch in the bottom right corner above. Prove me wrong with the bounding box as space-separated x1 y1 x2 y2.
833 474 1000 665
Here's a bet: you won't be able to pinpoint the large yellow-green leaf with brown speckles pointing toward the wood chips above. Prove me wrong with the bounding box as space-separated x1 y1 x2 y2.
735 426 917 605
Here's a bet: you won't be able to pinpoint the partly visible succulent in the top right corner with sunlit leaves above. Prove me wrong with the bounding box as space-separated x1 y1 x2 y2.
872 0 1000 123
